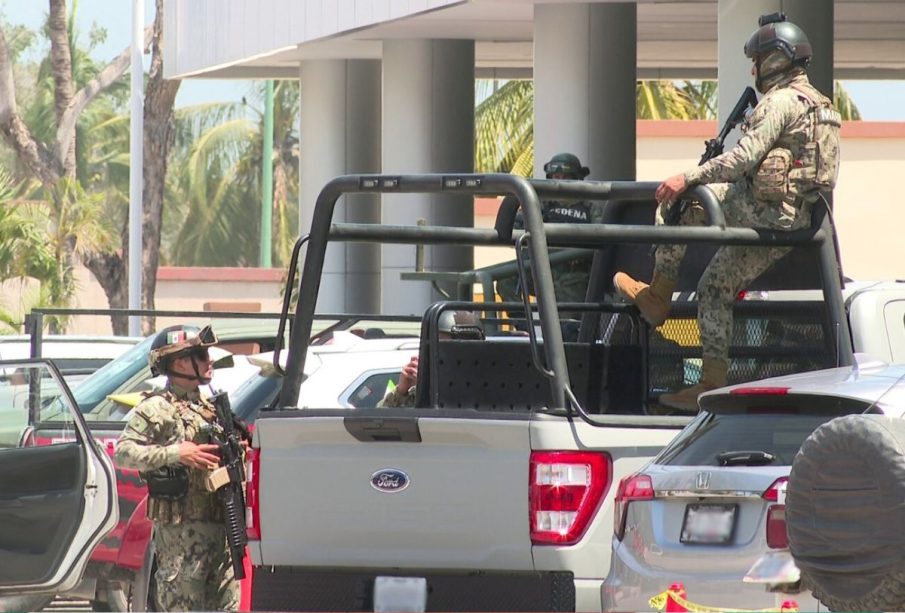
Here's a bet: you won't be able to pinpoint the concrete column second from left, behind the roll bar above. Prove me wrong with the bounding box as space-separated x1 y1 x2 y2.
381 40 474 315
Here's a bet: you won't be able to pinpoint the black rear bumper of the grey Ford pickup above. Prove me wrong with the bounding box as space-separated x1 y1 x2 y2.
251 567 576 611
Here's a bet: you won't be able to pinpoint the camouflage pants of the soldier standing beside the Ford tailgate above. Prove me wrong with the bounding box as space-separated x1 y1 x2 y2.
154 521 239 611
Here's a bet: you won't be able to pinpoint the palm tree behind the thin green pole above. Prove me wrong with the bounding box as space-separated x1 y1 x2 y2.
163 81 299 266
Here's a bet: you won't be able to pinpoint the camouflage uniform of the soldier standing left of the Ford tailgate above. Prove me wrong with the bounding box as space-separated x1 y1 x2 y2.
114 385 239 611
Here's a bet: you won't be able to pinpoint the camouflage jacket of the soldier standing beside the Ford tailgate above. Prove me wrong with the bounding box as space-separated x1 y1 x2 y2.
113 386 222 524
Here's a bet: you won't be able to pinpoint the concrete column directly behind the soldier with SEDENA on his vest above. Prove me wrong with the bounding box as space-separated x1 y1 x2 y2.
534 2 637 180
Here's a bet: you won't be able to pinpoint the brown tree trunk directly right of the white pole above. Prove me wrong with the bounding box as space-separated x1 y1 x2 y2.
141 0 181 334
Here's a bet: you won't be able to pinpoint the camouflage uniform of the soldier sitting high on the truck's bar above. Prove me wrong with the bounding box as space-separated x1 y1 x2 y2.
655 57 838 362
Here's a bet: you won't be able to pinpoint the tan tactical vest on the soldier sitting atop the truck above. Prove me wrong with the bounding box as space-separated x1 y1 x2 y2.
789 84 842 194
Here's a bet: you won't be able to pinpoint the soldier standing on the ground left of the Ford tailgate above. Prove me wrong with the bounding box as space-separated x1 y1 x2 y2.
114 326 239 611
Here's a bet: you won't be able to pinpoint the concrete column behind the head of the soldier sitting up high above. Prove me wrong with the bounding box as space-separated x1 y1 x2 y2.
717 0 833 132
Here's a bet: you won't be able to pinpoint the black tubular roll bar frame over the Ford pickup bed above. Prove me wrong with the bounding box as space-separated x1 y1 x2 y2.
280 174 853 414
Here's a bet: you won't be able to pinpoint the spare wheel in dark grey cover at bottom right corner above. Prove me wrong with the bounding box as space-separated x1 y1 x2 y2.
786 415 905 611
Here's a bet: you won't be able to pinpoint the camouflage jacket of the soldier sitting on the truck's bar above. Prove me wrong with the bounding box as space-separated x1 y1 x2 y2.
685 74 838 200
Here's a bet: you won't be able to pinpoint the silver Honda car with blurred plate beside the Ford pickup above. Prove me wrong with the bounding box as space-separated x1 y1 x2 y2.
602 355 902 611
